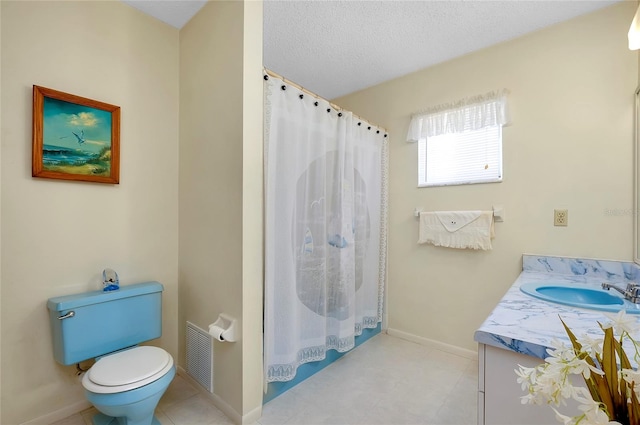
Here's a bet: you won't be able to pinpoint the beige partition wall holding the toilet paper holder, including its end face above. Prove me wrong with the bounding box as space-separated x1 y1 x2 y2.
179 1 262 420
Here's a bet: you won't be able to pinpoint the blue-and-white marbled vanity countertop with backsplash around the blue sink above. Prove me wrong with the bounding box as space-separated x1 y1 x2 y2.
474 255 640 359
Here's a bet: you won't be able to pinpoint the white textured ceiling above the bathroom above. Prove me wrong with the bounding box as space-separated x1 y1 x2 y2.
125 0 632 99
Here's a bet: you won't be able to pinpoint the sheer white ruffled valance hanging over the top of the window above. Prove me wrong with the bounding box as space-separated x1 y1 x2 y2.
407 89 509 142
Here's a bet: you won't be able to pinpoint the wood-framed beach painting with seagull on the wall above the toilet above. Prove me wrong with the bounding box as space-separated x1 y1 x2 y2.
32 85 120 184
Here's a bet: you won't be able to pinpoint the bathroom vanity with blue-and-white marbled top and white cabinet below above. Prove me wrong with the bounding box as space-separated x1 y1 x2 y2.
474 255 640 425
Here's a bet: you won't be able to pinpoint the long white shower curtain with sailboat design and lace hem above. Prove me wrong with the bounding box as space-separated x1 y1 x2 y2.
264 73 388 382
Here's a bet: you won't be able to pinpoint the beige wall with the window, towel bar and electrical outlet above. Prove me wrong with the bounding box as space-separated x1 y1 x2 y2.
335 2 638 350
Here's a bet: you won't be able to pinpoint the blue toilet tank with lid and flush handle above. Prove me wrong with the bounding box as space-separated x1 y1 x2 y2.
47 282 163 365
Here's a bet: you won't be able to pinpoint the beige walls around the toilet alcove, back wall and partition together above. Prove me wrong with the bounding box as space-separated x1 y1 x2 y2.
0 2 262 424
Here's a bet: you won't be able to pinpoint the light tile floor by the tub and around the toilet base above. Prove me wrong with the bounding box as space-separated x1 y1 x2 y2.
52 334 478 425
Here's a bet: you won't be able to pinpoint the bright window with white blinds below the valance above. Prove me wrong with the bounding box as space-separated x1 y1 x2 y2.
418 124 502 187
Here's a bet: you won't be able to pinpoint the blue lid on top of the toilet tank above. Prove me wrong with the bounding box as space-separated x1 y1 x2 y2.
47 282 164 311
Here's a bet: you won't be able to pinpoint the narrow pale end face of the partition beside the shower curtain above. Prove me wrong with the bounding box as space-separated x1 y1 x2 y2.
242 1 264 416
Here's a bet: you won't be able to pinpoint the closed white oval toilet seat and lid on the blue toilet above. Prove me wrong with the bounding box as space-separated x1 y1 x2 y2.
82 346 173 394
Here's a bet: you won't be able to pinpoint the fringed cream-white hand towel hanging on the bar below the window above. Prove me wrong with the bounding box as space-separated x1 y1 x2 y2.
418 211 494 250
